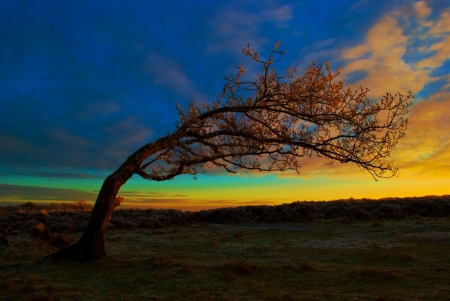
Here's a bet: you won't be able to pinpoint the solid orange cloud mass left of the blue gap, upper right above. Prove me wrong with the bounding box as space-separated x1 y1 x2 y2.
342 12 440 98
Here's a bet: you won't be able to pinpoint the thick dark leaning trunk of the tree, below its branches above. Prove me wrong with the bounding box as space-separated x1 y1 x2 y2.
44 137 167 262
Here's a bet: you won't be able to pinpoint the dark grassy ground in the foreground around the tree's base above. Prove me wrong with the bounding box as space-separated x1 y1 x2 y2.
0 217 450 301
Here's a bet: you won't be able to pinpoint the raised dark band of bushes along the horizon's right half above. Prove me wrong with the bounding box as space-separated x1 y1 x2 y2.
195 195 450 223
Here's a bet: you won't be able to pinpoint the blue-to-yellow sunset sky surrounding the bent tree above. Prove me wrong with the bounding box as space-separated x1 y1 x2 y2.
0 0 450 210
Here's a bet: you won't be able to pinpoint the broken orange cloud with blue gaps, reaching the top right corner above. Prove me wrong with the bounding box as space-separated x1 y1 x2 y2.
342 1 450 97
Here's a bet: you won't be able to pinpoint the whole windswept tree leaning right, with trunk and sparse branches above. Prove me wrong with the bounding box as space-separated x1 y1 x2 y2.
46 43 413 262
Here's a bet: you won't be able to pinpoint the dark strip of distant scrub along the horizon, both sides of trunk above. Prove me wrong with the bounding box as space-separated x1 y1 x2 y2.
0 195 450 233
